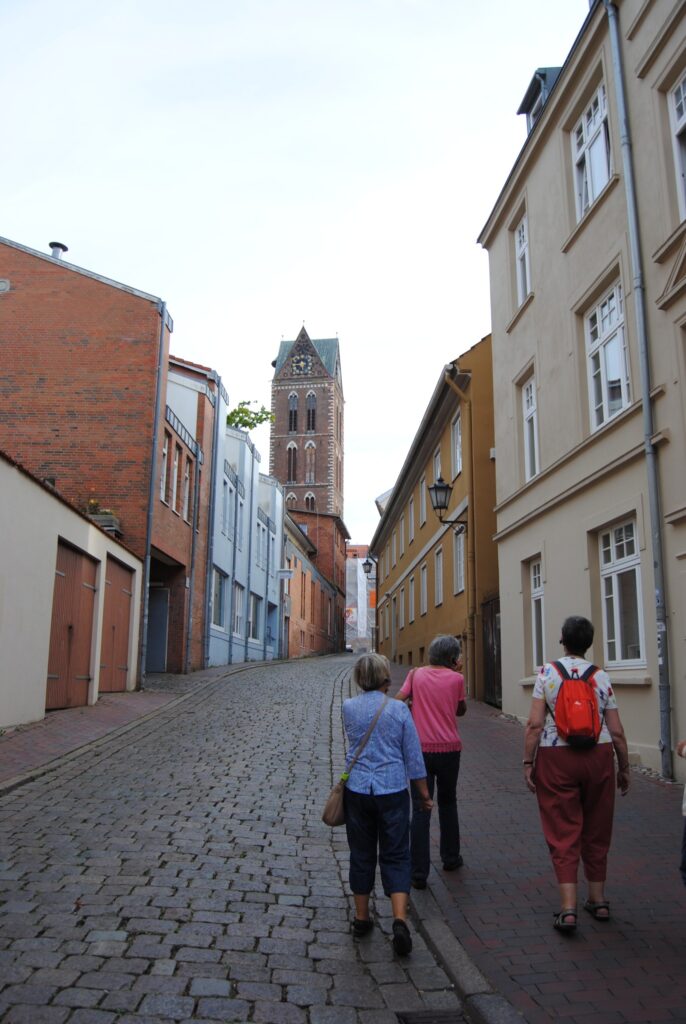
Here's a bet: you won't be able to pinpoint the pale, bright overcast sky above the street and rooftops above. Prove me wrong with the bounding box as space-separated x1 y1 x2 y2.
0 0 589 544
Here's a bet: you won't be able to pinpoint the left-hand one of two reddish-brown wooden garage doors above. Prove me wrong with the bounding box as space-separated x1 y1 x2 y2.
45 542 96 711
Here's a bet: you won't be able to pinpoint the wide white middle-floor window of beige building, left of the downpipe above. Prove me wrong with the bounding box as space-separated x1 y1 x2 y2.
586 285 631 430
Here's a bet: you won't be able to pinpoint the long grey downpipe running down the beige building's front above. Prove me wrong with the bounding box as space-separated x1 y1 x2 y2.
603 0 673 778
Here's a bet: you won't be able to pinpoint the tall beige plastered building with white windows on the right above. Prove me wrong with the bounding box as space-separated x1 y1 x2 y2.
479 0 686 773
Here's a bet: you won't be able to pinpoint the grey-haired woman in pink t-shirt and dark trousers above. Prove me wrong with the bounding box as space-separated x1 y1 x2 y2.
396 636 467 889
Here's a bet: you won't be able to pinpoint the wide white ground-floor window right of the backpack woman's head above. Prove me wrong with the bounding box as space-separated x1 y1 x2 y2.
600 521 643 665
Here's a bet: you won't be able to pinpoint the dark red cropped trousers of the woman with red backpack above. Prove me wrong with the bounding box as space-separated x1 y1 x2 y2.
534 743 614 882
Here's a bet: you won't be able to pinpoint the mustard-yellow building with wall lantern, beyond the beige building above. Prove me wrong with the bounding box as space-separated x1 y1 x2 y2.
370 337 500 705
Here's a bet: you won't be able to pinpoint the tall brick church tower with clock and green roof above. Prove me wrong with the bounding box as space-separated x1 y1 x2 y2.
269 327 343 518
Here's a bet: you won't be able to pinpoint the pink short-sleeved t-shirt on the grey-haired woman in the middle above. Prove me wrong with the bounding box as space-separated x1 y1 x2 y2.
397 665 467 754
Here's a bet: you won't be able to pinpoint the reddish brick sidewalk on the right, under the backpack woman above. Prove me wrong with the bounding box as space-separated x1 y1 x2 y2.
392 666 686 1024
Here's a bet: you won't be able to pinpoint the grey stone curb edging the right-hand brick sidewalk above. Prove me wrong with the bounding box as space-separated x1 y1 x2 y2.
412 889 524 1024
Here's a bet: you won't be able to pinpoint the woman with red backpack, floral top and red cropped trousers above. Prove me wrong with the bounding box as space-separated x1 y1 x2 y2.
522 615 630 932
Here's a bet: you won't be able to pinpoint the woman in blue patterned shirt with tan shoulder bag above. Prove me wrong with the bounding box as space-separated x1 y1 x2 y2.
343 654 432 955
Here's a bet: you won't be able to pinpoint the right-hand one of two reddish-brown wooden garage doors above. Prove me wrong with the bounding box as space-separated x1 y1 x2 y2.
98 556 133 693
